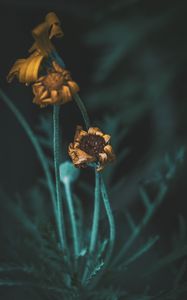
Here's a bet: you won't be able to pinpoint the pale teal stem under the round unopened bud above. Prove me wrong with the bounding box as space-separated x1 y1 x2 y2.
63 178 79 260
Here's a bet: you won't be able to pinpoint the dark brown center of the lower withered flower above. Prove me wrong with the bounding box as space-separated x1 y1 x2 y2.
79 134 105 158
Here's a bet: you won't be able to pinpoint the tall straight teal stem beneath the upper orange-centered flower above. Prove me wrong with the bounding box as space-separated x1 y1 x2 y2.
53 105 67 252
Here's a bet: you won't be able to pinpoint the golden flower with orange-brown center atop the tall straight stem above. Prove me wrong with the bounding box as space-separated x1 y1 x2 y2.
33 61 79 107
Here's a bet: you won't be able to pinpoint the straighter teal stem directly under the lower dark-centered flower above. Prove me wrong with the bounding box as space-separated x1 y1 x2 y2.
89 168 100 254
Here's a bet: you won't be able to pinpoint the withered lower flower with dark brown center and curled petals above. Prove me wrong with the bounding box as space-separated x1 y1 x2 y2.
68 126 115 171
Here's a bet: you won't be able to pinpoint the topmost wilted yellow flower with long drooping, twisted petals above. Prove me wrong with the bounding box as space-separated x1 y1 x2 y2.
7 12 63 84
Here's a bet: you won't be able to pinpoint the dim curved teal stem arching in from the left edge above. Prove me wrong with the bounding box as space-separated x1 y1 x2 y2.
0 89 56 216
